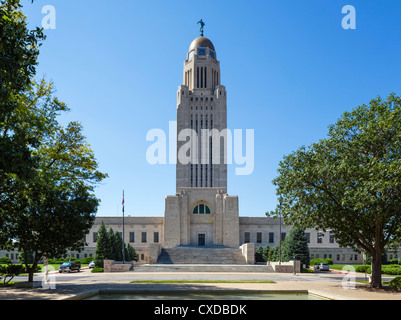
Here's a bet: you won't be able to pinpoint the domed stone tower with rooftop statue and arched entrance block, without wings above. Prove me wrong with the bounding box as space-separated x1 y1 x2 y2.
163 20 239 248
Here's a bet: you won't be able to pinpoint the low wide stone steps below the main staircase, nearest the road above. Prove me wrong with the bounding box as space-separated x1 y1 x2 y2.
133 264 274 273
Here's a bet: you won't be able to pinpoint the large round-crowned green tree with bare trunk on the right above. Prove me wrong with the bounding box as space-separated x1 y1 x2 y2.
273 93 401 288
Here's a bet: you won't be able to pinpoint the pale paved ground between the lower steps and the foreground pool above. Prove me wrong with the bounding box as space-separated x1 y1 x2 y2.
0 270 401 300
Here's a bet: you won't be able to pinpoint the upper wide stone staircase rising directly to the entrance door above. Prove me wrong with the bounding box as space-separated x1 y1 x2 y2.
157 246 247 265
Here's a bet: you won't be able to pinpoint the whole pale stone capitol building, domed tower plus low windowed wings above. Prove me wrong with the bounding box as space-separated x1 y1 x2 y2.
3 36 374 264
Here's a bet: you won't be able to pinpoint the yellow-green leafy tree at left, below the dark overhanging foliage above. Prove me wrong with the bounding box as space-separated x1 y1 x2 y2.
0 80 106 281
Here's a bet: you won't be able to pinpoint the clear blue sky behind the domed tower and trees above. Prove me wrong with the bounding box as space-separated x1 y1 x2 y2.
22 0 401 216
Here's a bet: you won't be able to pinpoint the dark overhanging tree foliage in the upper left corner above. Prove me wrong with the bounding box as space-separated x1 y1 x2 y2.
0 0 45 186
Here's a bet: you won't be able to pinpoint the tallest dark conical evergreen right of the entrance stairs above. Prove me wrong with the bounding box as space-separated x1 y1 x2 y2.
283 227 309 266
